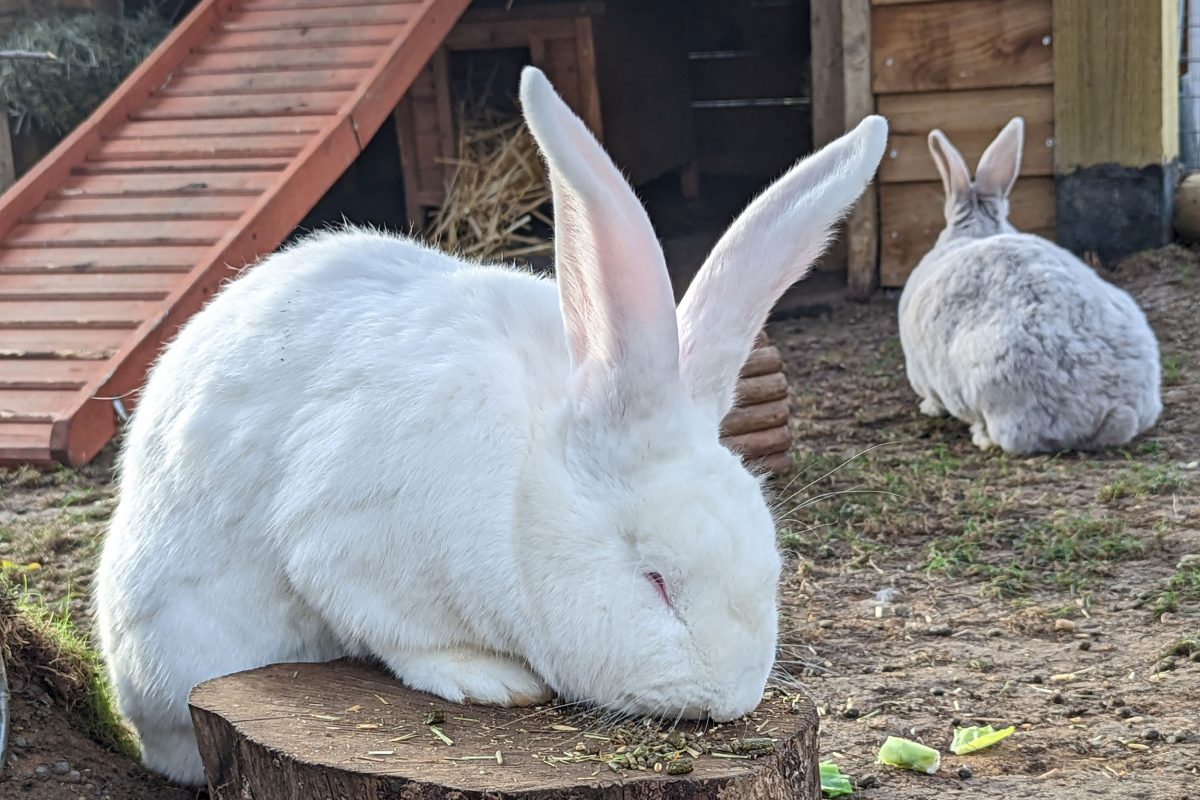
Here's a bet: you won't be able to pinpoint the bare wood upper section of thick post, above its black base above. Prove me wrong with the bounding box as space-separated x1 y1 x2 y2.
1054 0 1178 173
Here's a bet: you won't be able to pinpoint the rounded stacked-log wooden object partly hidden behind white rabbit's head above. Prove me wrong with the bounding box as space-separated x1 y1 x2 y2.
721 332 792 475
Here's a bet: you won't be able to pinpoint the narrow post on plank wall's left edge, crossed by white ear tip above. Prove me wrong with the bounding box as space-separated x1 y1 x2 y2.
841 0 880 297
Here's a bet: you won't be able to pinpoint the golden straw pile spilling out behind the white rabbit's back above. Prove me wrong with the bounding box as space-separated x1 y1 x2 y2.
425 103 554 261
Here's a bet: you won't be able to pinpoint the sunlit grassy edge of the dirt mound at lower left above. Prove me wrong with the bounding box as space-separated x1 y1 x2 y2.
0 576 138 758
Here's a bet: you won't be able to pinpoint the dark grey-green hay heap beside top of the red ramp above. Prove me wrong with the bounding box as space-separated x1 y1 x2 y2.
0 8 170 136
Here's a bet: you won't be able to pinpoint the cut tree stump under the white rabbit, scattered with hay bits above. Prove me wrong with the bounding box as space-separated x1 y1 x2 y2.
190 660 821 800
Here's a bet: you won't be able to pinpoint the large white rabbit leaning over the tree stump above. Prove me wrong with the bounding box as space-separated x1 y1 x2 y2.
97 68 887 783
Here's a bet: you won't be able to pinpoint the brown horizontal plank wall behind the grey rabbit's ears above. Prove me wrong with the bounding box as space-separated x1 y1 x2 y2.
870 0 1055 287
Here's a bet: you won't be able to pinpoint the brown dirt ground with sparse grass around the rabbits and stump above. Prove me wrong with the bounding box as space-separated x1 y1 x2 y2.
0 247 1200 800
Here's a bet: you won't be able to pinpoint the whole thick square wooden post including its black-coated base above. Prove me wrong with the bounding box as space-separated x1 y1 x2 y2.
1054 0 1178 261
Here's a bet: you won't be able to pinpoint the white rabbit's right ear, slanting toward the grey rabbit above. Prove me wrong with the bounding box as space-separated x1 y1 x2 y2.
678 116 888 422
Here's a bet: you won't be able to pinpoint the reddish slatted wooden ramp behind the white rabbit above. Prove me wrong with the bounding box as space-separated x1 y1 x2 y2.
0 0 469 465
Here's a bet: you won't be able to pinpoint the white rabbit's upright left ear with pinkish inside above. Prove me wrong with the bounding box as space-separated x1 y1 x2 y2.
521 67 679 413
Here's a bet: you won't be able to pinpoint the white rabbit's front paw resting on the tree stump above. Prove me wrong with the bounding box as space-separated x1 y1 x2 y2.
388 648 553 705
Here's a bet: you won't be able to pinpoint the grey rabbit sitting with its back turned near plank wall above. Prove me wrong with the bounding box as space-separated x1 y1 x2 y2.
900 116 1163 453
